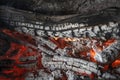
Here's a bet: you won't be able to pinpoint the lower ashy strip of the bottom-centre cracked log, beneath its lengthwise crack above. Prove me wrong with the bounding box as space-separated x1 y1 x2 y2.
42 54 91 74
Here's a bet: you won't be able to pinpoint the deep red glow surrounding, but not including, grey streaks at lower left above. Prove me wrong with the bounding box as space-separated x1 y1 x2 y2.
0 43 42 80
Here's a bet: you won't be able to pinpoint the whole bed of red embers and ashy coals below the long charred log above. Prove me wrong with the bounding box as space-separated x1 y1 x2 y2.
0 29 120 80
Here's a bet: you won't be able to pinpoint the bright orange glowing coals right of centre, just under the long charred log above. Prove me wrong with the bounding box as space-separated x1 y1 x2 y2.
50 37 116 62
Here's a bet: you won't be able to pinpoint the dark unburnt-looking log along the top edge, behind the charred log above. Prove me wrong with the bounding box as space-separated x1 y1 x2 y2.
0 0 120 15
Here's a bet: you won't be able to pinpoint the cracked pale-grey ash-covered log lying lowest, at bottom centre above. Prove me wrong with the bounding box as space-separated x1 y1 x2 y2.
42 56 101 75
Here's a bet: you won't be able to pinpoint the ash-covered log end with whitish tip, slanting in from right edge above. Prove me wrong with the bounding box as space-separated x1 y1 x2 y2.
95 40 120 64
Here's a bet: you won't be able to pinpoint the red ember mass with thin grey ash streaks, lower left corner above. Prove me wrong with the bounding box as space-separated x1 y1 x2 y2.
0 30 42 80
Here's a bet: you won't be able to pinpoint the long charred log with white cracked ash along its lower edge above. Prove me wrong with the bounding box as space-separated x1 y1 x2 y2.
0 6 120 40
